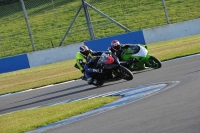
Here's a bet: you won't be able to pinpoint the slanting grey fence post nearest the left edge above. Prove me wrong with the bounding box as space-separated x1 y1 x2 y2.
20 0 36 51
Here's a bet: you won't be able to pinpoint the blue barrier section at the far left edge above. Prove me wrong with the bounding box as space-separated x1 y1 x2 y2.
0 54 30 73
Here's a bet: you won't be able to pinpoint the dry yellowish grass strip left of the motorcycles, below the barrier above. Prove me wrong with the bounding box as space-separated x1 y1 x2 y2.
0 60 81 94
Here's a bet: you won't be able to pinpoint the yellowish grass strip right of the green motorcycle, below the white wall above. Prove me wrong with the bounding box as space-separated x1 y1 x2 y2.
148 34 200 61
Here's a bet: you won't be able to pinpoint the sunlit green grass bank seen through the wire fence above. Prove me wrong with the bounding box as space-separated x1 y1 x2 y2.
0 0 200 57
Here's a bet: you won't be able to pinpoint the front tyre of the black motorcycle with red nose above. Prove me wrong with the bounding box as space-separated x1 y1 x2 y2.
118 66 133 80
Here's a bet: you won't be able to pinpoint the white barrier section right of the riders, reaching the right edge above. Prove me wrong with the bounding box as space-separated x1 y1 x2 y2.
143 18 200 44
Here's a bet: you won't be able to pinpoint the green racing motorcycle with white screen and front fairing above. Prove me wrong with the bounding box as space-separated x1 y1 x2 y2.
121 44 162 71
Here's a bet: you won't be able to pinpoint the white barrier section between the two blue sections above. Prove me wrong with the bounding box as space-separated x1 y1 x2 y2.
27 42 84 67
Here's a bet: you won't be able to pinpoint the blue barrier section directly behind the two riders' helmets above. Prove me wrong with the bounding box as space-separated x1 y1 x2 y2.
84 31 145 51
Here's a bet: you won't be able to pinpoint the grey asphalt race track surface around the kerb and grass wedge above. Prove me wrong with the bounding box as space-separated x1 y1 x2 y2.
0 55 200 133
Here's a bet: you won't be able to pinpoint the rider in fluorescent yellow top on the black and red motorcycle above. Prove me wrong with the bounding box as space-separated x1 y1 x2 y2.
75 45 106 84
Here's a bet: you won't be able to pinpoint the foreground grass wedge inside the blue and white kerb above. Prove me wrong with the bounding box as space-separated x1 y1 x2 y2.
0 97 118 133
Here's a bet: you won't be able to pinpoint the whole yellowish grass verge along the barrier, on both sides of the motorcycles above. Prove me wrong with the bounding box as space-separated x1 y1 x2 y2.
0 35 200 95
